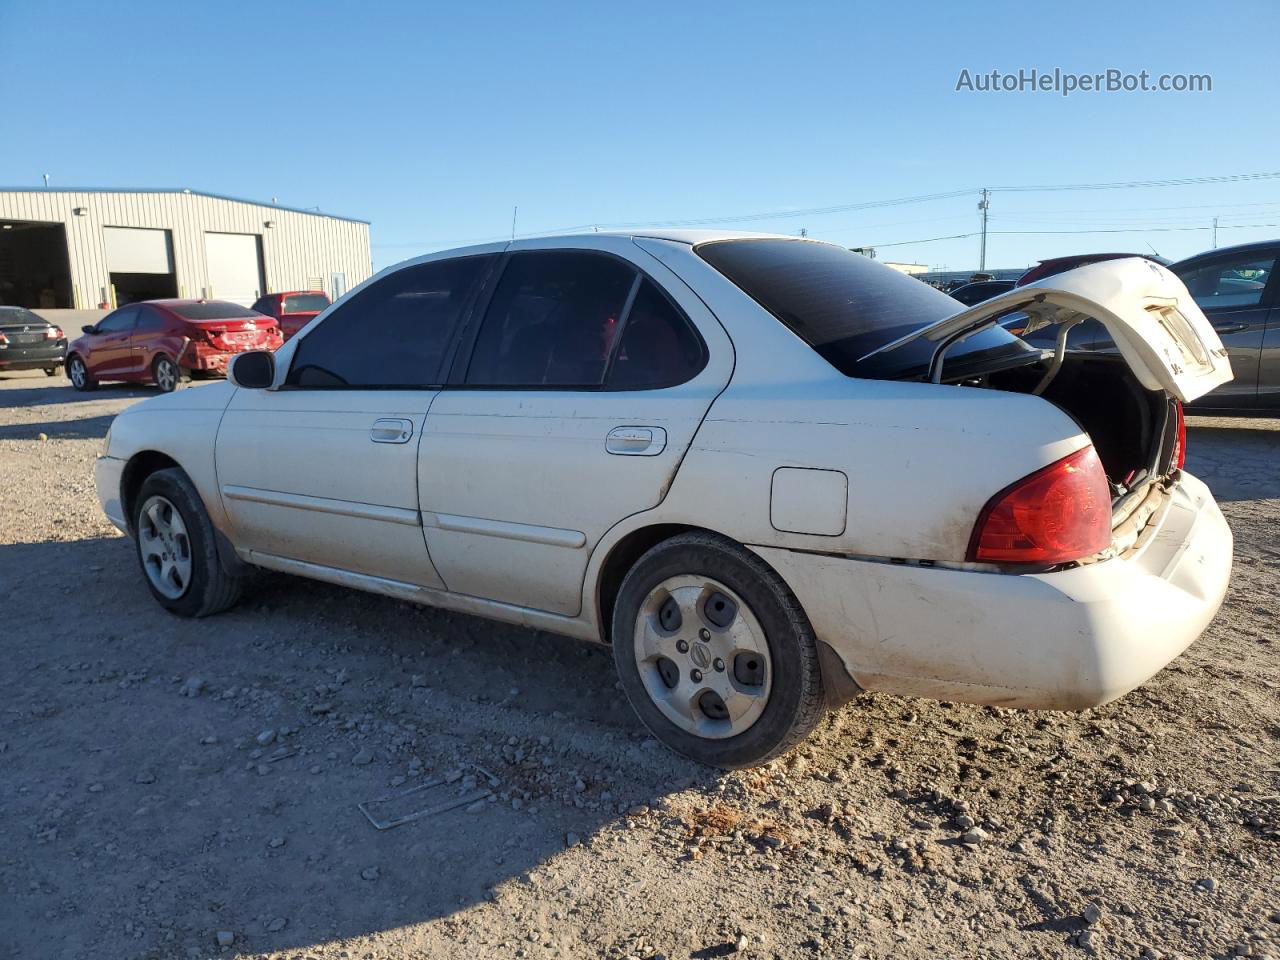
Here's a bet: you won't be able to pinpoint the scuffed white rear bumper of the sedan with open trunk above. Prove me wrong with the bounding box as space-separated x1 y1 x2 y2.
756 475 1231 709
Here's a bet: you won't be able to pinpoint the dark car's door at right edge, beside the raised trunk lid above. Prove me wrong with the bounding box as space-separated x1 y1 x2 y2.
1176 251 1276 410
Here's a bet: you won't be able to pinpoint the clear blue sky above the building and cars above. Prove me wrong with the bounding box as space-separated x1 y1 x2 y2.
0 0 1280 269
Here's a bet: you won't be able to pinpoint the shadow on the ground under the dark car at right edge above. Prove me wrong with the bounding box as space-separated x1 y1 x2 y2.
1187 419 1280 500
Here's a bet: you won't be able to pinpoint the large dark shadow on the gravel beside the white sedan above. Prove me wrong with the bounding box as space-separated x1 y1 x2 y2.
0 538 714 956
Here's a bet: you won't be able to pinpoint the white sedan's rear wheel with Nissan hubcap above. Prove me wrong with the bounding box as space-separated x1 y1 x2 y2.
612 532 826 768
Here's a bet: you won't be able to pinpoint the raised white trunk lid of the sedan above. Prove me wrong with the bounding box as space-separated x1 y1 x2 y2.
859 257 1233 403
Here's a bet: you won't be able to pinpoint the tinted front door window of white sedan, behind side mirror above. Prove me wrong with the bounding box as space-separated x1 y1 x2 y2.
285 257 493 387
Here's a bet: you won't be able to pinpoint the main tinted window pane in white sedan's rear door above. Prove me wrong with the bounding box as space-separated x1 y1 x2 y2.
466 252 636 387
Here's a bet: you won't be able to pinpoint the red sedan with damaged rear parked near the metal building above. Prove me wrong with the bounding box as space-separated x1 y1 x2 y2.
67 300 284 393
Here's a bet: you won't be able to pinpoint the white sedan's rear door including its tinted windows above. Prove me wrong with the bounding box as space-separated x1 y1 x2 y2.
419 237 732 616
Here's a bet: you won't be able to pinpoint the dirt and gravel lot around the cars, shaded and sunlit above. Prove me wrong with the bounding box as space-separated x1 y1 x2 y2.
0 374 1280 960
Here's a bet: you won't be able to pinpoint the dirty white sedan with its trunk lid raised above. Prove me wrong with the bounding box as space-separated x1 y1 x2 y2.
97 232 1231 767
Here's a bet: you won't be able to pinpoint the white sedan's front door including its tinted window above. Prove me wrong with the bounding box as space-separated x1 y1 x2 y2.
216 256 492 589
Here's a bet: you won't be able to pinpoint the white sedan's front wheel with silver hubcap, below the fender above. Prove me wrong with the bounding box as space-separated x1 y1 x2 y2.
133 467 243 617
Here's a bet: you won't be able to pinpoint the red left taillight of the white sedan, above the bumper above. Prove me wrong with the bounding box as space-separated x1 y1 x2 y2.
969 445 1111 566
